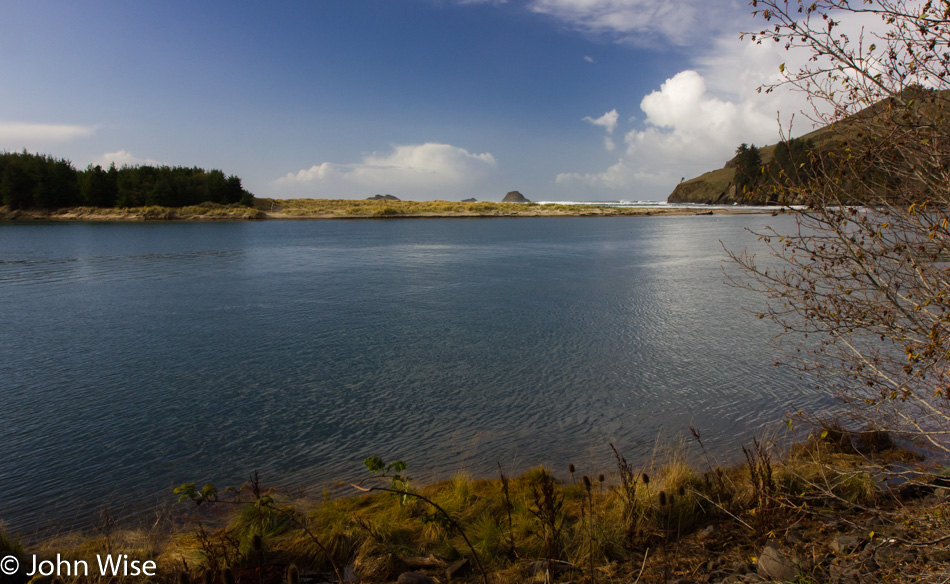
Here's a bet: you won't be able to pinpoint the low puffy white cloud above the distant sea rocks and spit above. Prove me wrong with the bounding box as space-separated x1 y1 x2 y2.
275 142 496 199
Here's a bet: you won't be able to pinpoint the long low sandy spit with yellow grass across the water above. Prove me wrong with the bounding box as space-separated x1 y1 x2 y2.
0 199 775 223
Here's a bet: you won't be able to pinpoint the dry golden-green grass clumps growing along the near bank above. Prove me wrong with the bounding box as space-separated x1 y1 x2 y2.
11 440 950 583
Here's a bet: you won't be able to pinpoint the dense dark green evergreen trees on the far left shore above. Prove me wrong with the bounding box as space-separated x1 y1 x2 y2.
0 150 254 209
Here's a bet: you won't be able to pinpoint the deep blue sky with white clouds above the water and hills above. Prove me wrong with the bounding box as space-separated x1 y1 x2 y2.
0 0 812 200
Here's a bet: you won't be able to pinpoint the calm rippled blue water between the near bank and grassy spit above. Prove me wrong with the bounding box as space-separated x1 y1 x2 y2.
0 215 821 531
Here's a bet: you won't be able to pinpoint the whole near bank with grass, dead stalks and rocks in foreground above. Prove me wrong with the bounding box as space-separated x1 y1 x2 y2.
7 428 950 584
